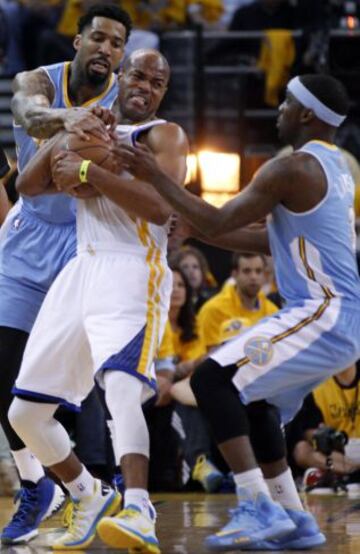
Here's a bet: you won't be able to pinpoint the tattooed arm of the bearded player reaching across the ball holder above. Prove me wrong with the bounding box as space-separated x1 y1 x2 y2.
11 69 109 140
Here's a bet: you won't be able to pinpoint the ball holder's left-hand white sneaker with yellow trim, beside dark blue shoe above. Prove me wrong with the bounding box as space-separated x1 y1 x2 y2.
52 479 121 550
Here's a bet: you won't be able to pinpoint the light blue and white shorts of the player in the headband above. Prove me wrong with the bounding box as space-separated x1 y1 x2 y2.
210 298 360 423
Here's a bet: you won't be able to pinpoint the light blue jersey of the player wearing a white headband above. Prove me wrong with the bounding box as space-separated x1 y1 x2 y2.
268 140 360 309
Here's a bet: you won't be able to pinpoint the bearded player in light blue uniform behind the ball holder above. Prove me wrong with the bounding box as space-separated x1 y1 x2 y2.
0 3 131 544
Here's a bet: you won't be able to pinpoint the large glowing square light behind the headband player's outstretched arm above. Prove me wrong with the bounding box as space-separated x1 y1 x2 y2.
198 150 240 193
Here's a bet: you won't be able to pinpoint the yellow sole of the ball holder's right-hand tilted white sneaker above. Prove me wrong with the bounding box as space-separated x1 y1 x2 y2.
96 519 160 554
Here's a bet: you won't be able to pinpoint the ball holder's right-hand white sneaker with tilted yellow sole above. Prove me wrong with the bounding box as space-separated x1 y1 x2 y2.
97 505 160 554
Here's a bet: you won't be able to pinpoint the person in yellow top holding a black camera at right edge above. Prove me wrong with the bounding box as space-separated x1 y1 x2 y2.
286 362 360 490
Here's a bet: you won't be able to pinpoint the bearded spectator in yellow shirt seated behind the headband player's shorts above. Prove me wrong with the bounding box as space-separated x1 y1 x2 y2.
198 253 278 350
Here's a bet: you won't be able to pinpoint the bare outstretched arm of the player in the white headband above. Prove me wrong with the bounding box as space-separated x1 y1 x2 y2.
122 142 292 238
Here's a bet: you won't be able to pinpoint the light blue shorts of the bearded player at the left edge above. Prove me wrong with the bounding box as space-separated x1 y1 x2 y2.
0 203 76 332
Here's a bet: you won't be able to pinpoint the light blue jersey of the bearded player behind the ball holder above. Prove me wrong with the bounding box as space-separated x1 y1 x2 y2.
14 62 118 223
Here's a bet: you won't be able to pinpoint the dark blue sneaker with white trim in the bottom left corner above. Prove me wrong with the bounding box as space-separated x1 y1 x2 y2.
1 477 65 544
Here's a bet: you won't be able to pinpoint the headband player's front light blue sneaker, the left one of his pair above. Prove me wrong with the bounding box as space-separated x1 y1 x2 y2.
205 490 296 552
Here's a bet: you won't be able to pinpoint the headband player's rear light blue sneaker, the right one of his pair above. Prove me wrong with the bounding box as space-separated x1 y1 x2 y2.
244 509 326 550
